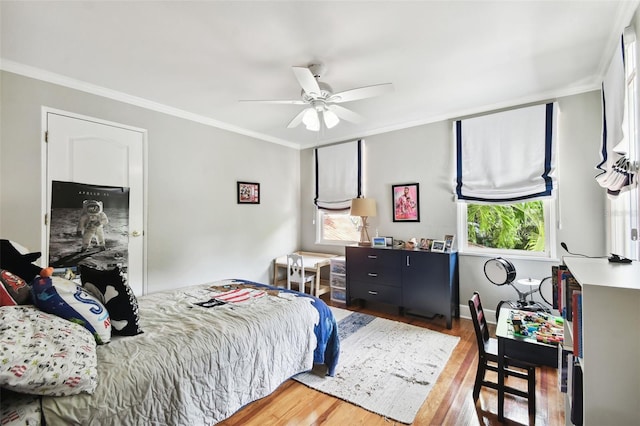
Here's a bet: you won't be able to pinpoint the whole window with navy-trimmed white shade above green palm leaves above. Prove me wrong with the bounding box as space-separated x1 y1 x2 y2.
454 103 557 258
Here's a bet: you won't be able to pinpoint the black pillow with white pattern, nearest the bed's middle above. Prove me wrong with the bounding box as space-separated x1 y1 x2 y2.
80 265 142 336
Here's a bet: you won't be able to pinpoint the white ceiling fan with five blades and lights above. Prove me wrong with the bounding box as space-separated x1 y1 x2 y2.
241 64 393 132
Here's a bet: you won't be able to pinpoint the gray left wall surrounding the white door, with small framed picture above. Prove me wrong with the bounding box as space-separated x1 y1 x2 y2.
0 72 300 291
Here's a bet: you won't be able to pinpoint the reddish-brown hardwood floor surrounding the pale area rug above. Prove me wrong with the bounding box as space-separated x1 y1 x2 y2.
219 302 564 426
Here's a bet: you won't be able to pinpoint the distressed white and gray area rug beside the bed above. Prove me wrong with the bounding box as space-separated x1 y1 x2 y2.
294 308 460 424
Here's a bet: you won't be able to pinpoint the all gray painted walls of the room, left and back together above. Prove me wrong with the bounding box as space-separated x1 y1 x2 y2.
0 72 606 312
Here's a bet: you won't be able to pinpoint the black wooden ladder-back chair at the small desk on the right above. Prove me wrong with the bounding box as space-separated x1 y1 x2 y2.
469 291 536 416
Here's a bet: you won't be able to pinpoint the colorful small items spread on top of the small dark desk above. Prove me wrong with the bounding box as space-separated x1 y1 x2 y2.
509 311 564 344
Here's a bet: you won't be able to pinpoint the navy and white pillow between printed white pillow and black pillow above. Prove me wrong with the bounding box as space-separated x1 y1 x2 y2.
31 277 111 344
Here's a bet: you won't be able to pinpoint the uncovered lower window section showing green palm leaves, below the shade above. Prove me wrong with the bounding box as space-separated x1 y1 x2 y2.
458 200 555 258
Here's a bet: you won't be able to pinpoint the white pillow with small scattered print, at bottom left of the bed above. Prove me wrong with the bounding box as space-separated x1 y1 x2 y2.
0 306 98 396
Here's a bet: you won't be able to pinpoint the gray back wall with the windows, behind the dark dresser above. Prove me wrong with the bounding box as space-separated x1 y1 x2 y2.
300 91 606 314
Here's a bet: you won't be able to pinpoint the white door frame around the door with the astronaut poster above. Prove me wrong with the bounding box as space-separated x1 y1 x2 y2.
40 106 149 294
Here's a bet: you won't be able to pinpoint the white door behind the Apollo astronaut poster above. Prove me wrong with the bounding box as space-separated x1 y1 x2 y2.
42 110 146 295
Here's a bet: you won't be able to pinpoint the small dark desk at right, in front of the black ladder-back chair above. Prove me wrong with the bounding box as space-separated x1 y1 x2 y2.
496 308 563 421
